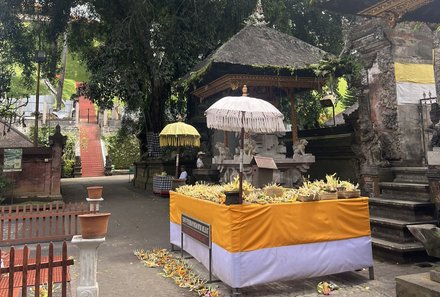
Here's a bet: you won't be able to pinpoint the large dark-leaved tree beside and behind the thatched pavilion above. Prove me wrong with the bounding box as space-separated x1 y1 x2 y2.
69 0 342 153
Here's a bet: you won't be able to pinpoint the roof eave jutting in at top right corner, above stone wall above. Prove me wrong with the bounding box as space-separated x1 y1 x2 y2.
315 0 440 23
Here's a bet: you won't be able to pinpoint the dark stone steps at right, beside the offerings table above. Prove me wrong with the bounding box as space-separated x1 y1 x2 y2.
369 167 436 263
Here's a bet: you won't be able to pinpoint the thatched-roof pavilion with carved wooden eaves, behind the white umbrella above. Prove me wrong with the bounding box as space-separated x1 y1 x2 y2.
184 24 327 148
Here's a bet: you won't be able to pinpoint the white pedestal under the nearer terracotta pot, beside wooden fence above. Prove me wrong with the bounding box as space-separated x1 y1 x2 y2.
72 235 105 297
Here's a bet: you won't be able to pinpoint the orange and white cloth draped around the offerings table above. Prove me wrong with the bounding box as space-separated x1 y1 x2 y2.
170 192 373 288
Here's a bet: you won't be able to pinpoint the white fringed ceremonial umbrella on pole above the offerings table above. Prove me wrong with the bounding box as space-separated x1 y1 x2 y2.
205 85 285 203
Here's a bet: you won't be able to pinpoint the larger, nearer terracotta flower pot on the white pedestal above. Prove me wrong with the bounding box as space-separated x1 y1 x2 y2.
78 213 111 239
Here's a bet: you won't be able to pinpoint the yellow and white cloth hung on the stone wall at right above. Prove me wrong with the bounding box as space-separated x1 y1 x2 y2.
394 63 436 105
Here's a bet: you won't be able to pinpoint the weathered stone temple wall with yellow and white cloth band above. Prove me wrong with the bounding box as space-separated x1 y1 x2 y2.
352 20 435 166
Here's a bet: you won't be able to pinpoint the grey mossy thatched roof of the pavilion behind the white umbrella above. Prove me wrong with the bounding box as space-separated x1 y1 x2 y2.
184 25 326 81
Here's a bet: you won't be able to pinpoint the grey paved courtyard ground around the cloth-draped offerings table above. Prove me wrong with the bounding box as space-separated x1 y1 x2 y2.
62 175 431 297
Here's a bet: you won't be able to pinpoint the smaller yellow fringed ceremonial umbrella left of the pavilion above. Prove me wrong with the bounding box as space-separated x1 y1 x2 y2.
159 122 200 178
